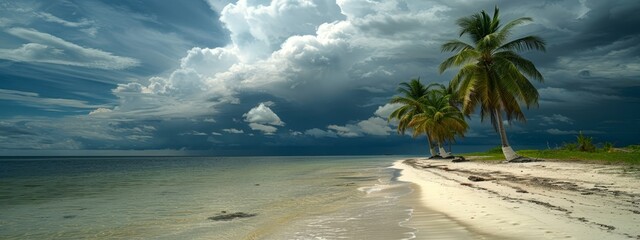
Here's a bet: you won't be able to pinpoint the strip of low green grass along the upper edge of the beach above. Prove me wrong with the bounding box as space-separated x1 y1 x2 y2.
463 145 640 165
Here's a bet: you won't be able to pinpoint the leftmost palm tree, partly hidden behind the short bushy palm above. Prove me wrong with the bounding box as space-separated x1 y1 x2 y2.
388 78 435 156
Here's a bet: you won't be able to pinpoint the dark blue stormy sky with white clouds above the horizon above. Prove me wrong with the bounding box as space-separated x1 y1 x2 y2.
0 0 640 155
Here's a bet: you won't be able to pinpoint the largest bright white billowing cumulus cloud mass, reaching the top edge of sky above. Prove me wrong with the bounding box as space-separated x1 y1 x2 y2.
96 0 460 120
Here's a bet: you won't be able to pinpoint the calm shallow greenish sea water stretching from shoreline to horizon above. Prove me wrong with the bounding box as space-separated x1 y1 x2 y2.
0 156 480 239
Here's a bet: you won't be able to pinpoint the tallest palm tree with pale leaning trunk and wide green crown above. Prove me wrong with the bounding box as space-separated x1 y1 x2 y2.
440 6 545 161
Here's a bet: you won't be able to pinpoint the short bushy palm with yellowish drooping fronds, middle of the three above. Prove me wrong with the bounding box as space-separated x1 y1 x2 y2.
409 84 469 158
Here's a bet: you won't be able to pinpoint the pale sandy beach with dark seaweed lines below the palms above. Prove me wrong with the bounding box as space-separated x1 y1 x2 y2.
393 159 640 239
